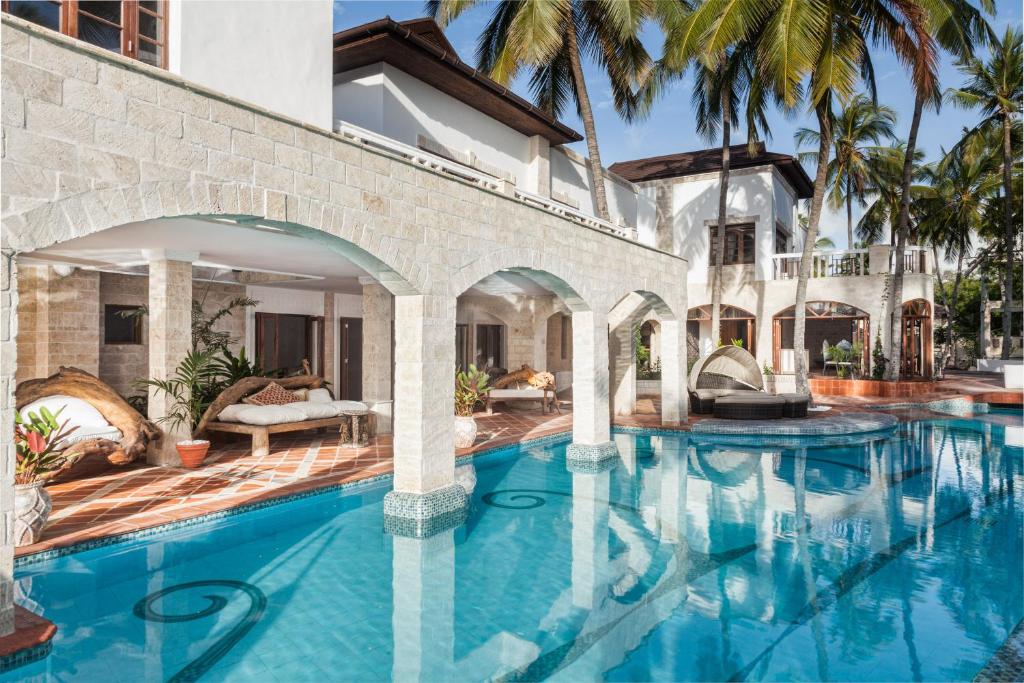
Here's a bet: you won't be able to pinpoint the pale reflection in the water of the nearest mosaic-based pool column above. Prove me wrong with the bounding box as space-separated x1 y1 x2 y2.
391 529 455 681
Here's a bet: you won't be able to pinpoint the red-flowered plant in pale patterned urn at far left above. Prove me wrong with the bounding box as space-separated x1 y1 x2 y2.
14 408 78 546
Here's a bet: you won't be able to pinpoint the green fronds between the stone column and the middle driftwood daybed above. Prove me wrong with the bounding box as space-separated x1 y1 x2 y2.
137 347 265 431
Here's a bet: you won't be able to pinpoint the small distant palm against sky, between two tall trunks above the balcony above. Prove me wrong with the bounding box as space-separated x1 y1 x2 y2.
796 95 896 249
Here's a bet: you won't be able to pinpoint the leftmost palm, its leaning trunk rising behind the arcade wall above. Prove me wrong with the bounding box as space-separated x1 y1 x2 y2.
426 0 655 220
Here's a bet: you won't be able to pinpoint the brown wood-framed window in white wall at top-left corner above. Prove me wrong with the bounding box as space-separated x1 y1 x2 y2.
3 0 167 67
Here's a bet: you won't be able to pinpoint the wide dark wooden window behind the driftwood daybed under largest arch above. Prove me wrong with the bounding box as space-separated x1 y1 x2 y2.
256 313 324 375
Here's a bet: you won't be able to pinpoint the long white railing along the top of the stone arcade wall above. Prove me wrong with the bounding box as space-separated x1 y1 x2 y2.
335 119 637 241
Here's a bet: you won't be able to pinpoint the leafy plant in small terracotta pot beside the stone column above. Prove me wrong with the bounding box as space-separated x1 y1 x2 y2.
139 350 218 469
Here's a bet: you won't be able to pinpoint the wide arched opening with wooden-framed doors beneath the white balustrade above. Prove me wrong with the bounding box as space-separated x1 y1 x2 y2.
772 301 871 373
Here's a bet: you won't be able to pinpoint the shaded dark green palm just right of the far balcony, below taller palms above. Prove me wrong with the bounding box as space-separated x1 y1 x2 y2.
913 142 999 369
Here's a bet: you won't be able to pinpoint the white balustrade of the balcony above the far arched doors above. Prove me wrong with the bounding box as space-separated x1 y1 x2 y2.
772 245 932 280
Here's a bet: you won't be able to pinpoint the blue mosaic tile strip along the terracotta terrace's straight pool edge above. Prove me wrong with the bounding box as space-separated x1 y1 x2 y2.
14 432 571 570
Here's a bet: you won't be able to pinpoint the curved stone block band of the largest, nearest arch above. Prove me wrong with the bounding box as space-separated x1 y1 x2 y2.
3 180 429 295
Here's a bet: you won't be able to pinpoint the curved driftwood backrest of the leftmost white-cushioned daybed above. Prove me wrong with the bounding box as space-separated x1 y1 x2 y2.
14 367 162 478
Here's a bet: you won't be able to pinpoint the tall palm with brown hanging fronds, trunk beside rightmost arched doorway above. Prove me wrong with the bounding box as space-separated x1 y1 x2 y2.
886 0 995 380
